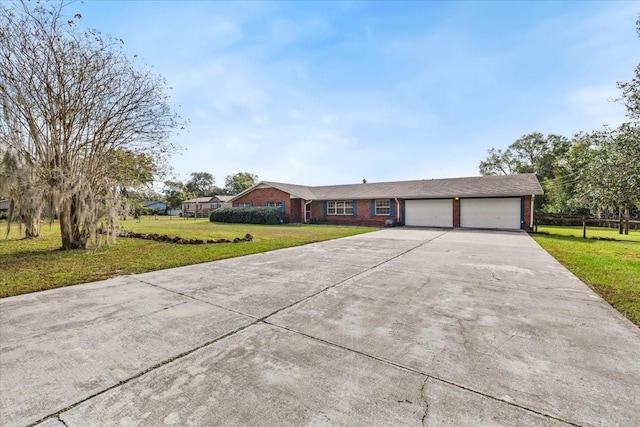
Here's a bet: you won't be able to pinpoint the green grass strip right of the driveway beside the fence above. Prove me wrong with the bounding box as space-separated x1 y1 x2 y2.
532 232 640 326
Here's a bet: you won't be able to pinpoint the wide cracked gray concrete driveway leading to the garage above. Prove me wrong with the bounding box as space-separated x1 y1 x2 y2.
0 228 640 427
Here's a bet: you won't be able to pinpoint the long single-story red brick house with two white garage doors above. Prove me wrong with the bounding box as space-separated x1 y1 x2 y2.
230 174 544 230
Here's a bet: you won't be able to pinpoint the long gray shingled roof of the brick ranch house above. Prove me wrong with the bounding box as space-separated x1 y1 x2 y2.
232 173 544 200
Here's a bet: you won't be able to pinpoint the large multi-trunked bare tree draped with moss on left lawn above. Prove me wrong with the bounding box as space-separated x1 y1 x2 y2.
0 2 179 249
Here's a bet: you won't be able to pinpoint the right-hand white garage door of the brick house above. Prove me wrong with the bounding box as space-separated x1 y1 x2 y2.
460 197 521 230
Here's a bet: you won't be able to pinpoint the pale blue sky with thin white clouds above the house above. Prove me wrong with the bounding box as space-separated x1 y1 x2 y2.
71 0 640 186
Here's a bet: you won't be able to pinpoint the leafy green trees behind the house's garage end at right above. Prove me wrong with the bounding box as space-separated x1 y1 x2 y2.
479 19 640 217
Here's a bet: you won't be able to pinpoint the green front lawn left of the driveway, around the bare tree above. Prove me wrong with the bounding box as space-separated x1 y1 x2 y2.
0 217 376 298
